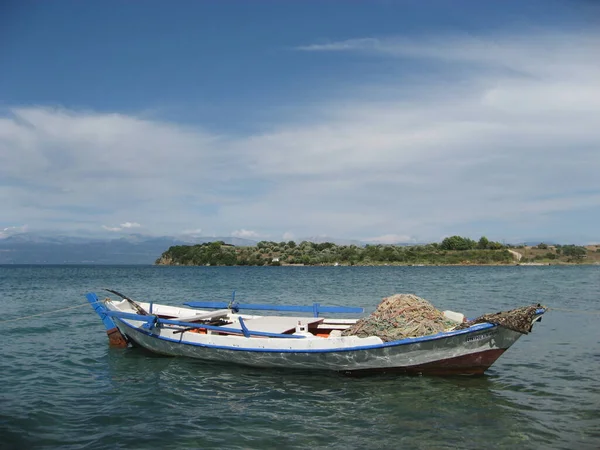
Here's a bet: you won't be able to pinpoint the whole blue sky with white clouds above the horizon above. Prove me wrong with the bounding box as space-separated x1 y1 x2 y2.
0 0 600 243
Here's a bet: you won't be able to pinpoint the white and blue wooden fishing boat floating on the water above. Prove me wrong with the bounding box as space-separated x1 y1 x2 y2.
87 291 546 375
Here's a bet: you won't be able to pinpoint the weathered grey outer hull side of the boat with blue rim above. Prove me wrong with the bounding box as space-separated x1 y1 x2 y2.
115 319 522 375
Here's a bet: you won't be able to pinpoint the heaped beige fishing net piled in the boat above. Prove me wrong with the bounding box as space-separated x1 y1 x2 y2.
342 294 456 342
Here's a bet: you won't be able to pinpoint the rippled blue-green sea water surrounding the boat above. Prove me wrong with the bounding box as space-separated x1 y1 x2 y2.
0 266 600 449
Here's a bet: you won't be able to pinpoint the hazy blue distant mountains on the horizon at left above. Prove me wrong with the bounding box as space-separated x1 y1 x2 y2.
0 233 256 264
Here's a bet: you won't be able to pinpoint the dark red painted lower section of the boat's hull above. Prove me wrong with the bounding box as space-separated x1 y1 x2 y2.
344 348 506 375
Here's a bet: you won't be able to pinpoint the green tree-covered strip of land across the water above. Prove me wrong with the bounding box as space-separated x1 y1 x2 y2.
156 236 600 266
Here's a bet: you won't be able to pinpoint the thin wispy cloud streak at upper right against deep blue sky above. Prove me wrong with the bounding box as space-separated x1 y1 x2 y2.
297 28 599 81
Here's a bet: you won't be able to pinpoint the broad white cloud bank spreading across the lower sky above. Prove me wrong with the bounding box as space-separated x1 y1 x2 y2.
0 30 600 241
